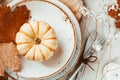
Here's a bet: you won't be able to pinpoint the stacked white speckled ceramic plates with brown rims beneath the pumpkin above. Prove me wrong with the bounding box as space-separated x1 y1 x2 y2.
9 0 81 79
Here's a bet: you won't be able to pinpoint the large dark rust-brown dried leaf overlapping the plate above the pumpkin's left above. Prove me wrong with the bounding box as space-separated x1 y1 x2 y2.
0 5 30 42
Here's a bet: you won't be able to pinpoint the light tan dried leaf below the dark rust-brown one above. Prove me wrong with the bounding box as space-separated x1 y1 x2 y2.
0 42 21 76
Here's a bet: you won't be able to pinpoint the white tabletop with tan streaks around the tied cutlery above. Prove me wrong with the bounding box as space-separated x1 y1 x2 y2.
78 0 120 80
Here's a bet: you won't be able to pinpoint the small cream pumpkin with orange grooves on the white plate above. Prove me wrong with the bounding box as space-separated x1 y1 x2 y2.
15 21 57 62
